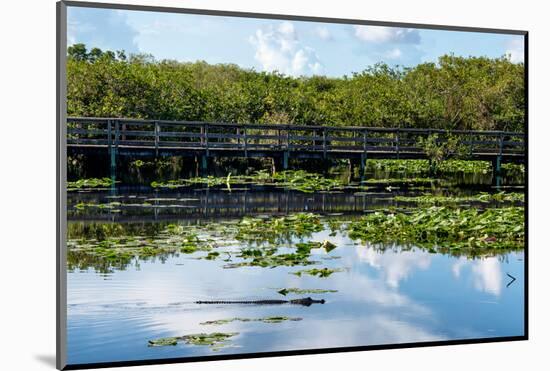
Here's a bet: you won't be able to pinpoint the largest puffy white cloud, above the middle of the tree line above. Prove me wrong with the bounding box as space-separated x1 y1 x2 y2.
249 22 323 76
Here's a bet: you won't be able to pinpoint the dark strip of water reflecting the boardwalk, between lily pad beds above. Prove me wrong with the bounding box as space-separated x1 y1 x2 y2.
67 183 521 222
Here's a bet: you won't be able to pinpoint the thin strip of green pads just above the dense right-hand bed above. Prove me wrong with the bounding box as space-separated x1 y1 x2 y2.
394 192 525 205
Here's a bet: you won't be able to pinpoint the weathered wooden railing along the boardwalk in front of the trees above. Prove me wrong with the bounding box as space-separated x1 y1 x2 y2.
67 117 525 161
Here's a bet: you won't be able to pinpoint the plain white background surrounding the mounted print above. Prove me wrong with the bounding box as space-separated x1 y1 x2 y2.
0 0 550 371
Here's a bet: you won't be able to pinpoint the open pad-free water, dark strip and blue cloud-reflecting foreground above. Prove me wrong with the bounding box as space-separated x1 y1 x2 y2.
68 189 524 364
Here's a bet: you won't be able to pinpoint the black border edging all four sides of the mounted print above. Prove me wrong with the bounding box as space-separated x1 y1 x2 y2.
56 0 529 370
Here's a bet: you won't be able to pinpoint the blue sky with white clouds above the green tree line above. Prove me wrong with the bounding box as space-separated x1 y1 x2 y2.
67 7 523 76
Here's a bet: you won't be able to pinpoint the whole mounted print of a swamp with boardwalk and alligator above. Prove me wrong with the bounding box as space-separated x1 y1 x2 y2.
59 2 527 368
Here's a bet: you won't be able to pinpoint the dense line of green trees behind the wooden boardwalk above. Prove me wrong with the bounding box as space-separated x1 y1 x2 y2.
67 44 525 131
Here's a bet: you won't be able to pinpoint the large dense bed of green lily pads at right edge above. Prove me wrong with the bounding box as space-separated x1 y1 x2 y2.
348 206 524 252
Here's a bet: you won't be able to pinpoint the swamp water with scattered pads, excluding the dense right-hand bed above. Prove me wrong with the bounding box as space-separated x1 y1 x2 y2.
67 186 524 364
